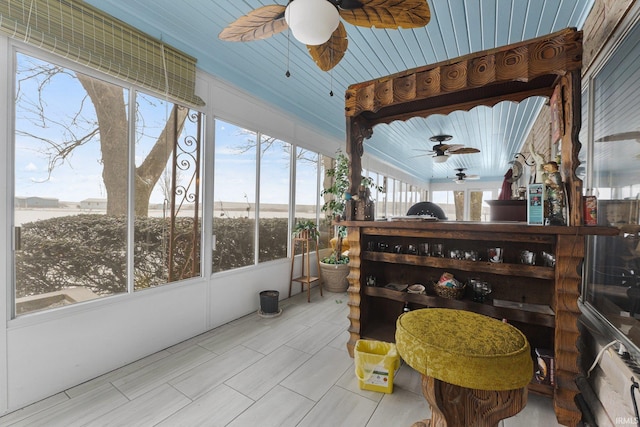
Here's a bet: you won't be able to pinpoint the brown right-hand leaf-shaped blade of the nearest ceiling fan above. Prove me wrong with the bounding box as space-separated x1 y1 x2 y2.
338 0 431 29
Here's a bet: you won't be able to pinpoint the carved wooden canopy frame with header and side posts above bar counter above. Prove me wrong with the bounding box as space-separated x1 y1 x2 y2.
345 28 582 225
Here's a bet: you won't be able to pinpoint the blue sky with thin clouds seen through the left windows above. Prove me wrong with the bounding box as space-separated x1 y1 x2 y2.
15 54 317 210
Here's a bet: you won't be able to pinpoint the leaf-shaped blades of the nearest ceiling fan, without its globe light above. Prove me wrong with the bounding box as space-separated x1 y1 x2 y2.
218 0 431 71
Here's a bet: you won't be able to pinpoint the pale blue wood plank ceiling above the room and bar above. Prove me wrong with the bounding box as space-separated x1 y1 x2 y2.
86 0 594 182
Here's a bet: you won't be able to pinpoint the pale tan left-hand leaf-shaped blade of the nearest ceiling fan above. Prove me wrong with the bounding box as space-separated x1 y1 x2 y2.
218 4 288 42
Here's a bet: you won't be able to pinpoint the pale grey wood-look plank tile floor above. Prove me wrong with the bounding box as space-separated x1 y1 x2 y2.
0 288 558 427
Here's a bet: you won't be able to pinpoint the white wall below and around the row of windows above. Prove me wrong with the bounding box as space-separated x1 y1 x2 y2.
0 44 343 414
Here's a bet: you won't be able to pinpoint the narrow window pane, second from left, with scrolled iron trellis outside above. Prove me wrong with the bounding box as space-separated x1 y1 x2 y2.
133 93 202 290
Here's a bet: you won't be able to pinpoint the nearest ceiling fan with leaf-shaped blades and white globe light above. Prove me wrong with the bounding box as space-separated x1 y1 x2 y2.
218 0 431 71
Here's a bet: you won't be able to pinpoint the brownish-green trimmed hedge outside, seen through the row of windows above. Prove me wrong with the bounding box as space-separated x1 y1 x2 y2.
15 215 289 298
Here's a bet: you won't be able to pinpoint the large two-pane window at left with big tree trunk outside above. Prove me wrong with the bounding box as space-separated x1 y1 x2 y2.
13 53 200 315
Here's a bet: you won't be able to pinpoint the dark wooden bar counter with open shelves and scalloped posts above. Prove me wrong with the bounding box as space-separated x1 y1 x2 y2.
341 219 617 425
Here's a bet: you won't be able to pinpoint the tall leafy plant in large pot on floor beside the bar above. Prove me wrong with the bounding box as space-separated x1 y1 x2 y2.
320 151 382 292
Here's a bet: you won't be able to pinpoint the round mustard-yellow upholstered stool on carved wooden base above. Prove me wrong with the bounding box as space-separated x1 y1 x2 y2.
396 308 533 427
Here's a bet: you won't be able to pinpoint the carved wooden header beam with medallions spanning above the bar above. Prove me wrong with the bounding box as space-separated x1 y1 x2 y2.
345 28 582 125
